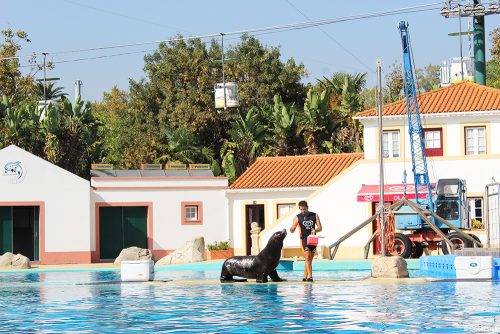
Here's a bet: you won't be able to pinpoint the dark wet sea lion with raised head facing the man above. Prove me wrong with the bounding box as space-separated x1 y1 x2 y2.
220 229 286 283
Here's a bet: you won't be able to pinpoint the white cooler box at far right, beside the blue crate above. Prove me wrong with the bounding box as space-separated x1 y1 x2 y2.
455 256 493 279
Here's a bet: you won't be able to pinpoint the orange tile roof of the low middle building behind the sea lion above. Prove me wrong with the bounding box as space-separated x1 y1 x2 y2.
230 153 364 189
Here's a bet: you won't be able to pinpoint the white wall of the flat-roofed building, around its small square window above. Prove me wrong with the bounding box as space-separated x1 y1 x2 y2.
91 177 230 250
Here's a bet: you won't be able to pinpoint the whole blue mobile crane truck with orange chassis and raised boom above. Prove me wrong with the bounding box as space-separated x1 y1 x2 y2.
391 21 480 258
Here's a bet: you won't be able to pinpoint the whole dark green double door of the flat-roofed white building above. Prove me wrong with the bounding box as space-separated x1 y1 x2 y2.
99 206 148 259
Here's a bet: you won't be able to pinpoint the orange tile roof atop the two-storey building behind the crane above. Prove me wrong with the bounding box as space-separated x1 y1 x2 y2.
356 81 500 117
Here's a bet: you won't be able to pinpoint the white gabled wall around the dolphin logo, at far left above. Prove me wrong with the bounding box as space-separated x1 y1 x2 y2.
0 146 90 252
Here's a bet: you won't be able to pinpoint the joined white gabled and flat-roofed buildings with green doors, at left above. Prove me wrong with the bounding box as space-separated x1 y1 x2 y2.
0 145 229 264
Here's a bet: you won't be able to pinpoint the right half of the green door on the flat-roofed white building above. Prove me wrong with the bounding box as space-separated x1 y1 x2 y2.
123 206 148 248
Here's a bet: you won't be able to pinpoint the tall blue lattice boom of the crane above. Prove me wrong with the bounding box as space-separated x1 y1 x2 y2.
398 21 434 211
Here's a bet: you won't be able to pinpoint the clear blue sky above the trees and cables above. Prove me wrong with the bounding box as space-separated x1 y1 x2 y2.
0 0 500 101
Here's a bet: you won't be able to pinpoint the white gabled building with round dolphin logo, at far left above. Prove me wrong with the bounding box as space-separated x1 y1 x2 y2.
0 145 92 264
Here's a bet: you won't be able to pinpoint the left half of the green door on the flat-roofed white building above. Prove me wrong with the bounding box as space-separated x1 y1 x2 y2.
99 207 123 259
